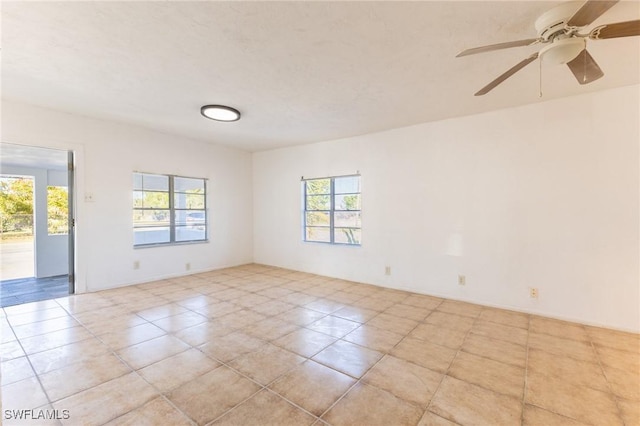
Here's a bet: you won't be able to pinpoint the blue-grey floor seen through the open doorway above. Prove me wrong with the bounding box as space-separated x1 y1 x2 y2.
0 275 69 308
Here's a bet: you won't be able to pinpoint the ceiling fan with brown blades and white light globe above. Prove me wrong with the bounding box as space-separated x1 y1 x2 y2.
456 0 640 96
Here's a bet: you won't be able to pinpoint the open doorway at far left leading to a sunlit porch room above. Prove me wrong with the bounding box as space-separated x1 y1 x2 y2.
0 143 74 307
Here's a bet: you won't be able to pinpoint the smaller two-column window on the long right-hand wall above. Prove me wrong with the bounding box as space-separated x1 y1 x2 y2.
302 175 362 245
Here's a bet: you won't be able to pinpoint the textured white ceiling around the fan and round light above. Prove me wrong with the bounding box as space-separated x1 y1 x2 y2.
2 1 640 151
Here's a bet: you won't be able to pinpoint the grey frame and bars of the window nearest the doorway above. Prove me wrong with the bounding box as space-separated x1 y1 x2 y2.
132 171 209 249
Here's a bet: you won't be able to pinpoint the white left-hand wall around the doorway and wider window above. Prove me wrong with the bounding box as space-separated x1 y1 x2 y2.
2 100 253 292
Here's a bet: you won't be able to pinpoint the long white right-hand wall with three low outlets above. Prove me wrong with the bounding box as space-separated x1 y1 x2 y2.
253 86 640 332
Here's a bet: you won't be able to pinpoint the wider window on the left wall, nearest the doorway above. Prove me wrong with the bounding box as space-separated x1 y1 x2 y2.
133 173 207 247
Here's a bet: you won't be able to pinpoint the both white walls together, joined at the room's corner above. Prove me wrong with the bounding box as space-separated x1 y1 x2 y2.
1 86 640 332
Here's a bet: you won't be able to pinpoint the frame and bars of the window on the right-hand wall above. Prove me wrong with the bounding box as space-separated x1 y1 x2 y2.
301 173 362 247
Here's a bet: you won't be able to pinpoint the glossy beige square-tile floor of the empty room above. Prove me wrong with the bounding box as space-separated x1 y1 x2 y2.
0 265 640 426
